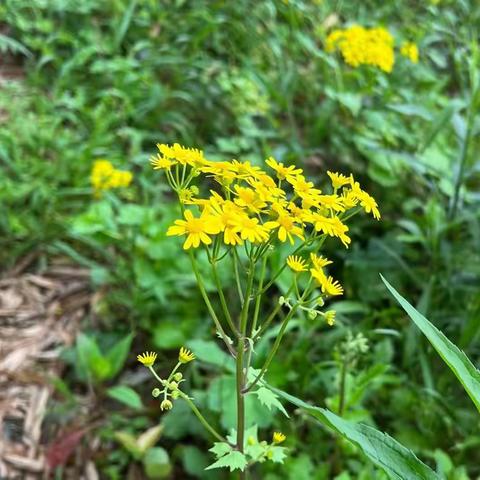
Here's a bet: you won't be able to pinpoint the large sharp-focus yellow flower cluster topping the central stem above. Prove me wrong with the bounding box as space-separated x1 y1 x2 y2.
151 144 380 253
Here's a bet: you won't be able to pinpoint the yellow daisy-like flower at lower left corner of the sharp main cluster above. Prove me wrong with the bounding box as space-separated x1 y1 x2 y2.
167 210 221 250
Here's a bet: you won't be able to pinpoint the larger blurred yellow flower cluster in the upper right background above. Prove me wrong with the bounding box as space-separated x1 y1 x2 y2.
326 25 395 73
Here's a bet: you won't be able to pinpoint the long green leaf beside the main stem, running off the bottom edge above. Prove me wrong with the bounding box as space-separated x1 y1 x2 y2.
272 388 439 480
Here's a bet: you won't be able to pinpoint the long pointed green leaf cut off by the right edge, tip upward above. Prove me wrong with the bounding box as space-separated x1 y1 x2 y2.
380 275 480 411
